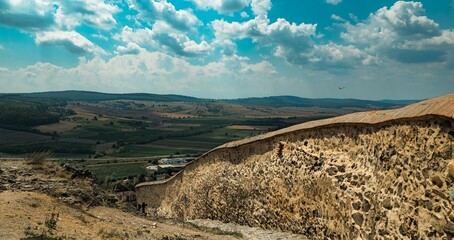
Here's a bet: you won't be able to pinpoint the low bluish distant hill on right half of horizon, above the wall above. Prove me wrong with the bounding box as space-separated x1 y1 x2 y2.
227 96 411 109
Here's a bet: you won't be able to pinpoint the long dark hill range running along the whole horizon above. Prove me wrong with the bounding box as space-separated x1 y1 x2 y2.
13 91 416 109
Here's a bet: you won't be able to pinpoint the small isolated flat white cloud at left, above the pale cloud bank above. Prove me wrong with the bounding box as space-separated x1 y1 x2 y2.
35 31 105 54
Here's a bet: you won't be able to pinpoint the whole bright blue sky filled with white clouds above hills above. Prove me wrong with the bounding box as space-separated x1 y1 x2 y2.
0 0 454 100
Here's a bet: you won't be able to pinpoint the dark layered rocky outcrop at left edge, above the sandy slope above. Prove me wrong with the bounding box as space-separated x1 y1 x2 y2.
0 161 118 207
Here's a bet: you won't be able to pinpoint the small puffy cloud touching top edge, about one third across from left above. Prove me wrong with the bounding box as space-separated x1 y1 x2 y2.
128 0 200 31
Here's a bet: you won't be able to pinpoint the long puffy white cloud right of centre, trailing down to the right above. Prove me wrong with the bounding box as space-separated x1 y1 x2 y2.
211 16 379 69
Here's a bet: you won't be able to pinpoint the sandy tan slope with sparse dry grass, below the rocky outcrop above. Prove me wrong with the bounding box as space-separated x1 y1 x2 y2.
0 191 236 240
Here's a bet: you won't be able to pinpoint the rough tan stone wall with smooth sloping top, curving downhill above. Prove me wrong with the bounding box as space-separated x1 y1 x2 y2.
136 95 454 239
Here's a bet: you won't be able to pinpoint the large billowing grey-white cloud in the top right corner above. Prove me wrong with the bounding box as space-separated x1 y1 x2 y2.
341 1 453 63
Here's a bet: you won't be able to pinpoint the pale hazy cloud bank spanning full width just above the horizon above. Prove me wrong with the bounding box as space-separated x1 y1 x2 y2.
0 51 454 99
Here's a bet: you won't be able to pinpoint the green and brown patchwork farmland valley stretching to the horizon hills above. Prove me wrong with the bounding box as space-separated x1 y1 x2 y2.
0 91 412 182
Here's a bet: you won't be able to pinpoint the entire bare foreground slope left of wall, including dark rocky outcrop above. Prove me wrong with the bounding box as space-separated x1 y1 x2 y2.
0 161 254 240
